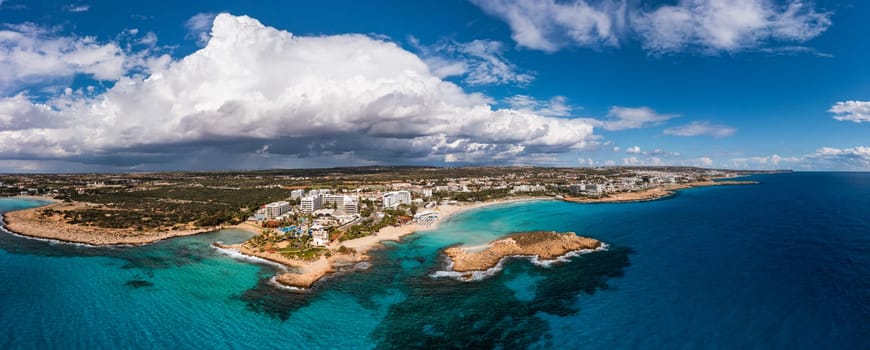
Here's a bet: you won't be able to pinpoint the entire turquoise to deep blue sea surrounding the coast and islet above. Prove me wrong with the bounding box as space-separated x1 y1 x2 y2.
0 173 870 349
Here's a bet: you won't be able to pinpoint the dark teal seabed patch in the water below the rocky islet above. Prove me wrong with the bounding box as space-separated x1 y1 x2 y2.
373 247 632 349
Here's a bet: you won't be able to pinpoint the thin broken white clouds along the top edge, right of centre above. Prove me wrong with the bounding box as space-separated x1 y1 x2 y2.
472 0 831 54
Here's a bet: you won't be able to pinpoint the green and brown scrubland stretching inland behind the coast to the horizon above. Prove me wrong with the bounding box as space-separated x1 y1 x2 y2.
0 166 768 231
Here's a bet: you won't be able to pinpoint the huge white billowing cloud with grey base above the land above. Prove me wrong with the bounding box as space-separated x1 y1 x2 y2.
0 14 593 170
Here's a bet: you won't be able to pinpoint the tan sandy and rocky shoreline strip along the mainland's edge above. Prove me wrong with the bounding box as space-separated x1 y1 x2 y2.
3 181 758 290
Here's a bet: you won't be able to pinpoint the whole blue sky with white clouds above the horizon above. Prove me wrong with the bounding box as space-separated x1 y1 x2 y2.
0 0 870 173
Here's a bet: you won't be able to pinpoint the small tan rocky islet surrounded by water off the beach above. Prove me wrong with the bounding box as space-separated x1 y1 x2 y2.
444 231 602 272
